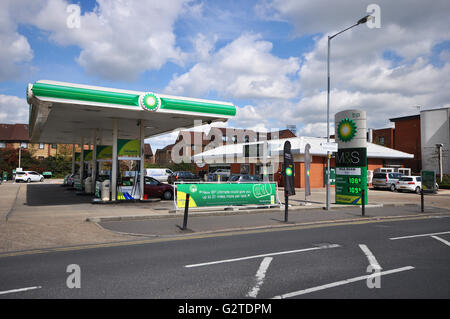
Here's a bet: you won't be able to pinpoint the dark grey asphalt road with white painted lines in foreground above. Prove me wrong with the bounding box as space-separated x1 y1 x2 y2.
0 216 450 299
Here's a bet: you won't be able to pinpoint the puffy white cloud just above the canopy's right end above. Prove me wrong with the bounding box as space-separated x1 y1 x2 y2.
165 34 299 99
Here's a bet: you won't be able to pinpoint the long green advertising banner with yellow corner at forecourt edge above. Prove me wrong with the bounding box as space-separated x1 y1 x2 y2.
176 183 277 208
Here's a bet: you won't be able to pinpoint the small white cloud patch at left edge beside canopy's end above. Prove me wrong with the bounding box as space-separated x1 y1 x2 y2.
0 94 29 124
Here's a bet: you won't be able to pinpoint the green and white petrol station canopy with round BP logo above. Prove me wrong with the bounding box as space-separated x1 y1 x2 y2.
27 81 236 144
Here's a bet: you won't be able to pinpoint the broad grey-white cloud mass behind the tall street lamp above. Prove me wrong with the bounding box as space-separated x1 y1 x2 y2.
244 0 450 136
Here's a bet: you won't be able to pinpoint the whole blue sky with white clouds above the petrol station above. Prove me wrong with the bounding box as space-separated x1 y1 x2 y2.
0 0 450 151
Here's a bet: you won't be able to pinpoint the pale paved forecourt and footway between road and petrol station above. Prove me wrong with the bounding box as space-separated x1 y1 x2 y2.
0 179 450 254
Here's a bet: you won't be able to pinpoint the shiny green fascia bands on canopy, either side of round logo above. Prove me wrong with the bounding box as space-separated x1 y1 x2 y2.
32 82 236 116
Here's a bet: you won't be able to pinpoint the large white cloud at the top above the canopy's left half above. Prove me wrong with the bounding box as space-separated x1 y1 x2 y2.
27 0 188 80
